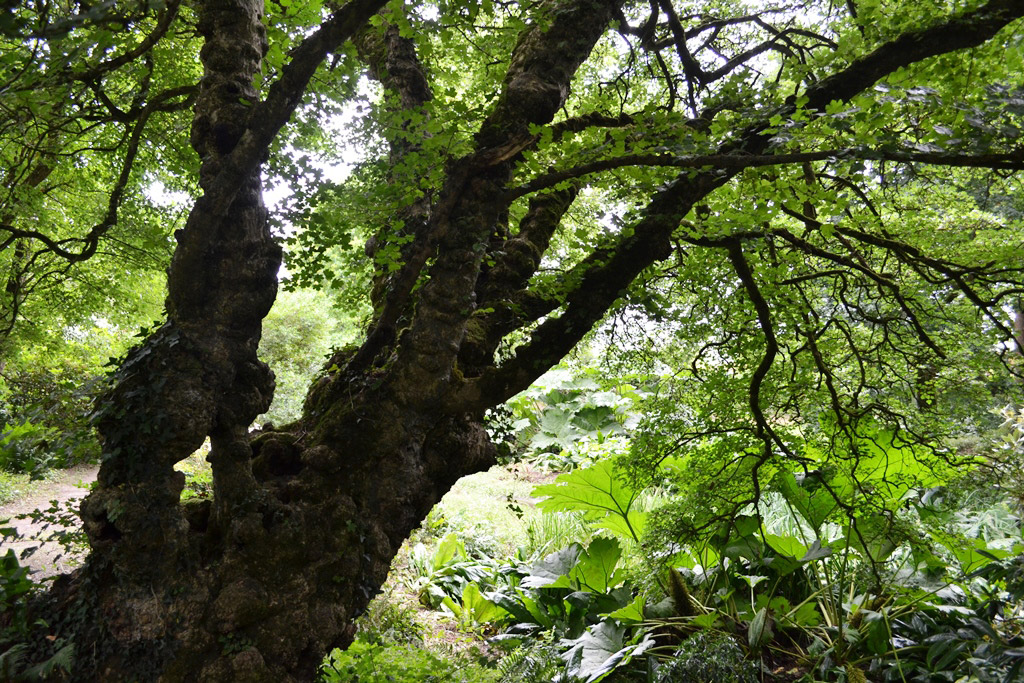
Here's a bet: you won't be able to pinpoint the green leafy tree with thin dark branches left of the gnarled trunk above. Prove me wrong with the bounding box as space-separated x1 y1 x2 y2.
0 1 200 362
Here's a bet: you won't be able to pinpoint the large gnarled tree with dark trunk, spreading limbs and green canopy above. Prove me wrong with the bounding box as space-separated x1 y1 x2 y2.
8 0 1024 680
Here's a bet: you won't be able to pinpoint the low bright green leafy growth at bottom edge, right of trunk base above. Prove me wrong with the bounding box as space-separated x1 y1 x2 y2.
321 640 498 683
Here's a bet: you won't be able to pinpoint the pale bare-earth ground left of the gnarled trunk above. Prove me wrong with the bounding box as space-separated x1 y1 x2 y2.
0 465 99 581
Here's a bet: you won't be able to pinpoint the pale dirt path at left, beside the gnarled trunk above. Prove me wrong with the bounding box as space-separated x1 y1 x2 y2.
0 465 99 581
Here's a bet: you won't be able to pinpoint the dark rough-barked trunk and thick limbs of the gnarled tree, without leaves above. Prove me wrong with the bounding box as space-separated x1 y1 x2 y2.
16 0 1024 681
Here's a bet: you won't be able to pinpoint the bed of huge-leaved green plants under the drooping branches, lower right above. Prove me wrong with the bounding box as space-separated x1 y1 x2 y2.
360 385 1024 683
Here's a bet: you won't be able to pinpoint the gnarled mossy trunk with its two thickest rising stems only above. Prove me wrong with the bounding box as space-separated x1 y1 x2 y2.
32 0 612 681
